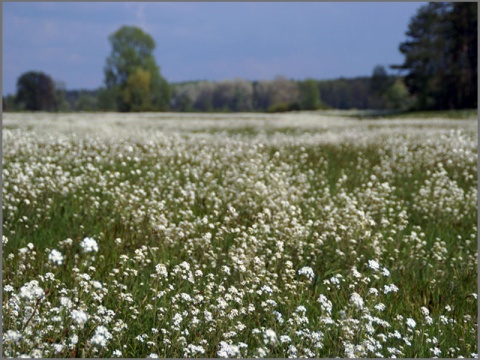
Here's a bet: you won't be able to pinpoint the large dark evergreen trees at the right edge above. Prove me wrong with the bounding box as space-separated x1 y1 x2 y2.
393 3 478 109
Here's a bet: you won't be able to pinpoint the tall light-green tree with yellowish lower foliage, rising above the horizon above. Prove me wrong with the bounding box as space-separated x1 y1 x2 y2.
105 26 170 111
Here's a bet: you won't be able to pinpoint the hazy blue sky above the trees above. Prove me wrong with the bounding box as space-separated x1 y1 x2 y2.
2 2 426 95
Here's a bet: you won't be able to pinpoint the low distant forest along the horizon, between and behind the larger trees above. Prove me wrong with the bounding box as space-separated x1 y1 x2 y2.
4 71 411 112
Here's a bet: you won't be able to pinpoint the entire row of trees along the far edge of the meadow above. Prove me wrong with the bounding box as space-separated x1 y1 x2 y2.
3 3 478 112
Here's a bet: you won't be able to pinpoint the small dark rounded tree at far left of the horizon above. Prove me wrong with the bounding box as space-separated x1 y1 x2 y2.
15 71 57 111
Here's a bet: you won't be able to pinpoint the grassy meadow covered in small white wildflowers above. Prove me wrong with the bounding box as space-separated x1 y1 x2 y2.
2 113 478 358
